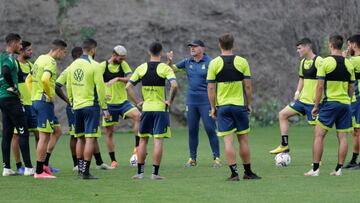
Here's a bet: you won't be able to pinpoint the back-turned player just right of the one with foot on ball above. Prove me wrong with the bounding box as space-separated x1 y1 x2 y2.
304 35 355 176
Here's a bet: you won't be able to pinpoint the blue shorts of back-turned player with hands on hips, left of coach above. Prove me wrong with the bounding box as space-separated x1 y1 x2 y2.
139 111 171 138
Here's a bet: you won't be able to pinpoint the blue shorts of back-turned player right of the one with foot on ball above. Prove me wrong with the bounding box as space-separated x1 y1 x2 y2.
316 101 353 132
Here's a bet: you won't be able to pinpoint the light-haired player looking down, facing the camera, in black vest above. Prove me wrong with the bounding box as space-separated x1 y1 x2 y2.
100 45 140 167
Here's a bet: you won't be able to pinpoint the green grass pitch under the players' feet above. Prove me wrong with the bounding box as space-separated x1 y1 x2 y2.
0 126 360 202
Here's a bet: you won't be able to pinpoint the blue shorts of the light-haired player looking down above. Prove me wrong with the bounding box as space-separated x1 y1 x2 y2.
103 101 136 126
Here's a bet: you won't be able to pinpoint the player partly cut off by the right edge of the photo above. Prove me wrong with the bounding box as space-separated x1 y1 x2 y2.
344 34 360 169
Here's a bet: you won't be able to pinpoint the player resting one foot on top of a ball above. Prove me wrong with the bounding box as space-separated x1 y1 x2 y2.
270 38 322 154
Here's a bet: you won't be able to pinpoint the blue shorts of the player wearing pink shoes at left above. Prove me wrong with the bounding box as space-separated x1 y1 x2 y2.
33 101 59 133
